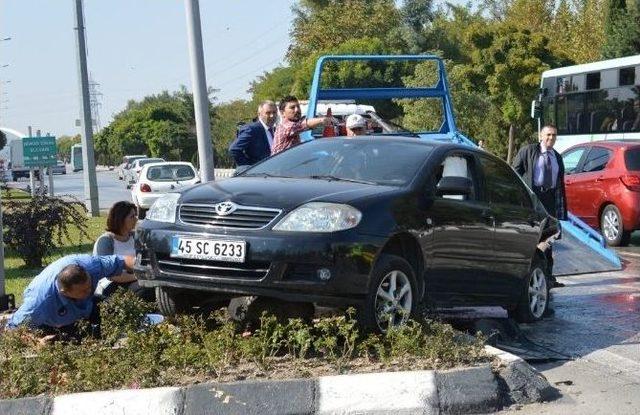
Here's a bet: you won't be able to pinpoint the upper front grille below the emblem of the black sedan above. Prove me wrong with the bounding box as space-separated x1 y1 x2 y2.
179 203 280 229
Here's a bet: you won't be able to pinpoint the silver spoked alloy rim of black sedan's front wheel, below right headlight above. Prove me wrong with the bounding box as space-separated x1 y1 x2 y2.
375 270 413 332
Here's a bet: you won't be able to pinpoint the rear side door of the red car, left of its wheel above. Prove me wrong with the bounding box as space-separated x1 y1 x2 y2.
571 145 612 227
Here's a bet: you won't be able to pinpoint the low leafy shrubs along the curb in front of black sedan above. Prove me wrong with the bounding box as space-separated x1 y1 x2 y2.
0 306 487 399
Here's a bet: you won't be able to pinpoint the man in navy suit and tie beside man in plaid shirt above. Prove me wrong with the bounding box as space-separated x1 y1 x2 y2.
229 101 278 167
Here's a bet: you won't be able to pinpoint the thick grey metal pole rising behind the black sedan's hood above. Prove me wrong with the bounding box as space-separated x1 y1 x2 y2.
184 0 215 182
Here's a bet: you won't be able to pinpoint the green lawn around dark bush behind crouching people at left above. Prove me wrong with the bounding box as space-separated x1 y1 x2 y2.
2 189 107 306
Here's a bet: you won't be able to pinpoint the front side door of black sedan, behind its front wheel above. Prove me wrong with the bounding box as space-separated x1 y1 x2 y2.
424 150 494 302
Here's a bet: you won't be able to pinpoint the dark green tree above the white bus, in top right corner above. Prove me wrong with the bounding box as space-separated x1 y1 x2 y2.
602 0 640 59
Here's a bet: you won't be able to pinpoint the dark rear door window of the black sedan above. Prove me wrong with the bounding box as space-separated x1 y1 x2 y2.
480 155 531 207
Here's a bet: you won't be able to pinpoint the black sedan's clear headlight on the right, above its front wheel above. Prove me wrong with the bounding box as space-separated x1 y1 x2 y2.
273 202 362 232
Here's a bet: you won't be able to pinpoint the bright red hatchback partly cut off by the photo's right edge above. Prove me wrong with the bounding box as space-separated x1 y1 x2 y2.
562 140 640 246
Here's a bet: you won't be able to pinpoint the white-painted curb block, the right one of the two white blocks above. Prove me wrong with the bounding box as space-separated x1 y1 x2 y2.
316 371 439 414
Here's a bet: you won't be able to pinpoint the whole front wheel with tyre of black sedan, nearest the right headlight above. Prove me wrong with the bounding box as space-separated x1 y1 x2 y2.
358 254 419 333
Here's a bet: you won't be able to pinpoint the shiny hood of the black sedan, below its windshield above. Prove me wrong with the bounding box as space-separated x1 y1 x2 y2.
180 177 400 209
